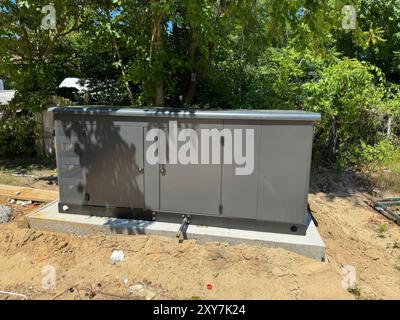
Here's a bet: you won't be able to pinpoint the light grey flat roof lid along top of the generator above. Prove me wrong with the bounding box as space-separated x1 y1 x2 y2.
48 106 321 121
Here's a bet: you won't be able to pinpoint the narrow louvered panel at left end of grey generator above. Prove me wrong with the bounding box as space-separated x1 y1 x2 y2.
54 115 86 205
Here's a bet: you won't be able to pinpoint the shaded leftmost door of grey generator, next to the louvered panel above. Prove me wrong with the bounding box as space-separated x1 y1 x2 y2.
85 116 145 209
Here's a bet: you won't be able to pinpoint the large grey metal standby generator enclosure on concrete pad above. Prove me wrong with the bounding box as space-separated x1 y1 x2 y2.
49 107 320 235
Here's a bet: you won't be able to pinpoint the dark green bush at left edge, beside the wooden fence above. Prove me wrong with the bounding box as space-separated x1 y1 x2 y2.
0 115 38 156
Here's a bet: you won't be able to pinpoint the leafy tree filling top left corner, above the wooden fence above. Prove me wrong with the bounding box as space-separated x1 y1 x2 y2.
0 0 87 110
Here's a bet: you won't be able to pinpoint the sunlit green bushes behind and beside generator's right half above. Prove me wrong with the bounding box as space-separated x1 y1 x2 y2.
201 47 400 167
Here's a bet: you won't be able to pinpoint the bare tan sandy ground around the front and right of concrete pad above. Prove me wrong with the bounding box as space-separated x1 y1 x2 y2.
0 170 400 299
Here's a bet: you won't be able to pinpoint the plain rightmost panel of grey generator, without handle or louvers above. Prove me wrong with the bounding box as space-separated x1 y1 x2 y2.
257 122 313 225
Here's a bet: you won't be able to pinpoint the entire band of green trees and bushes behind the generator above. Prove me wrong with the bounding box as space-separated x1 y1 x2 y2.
0 0 400 167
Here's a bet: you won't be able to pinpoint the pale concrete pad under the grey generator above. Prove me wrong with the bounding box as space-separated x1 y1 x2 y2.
27 201 325 260
